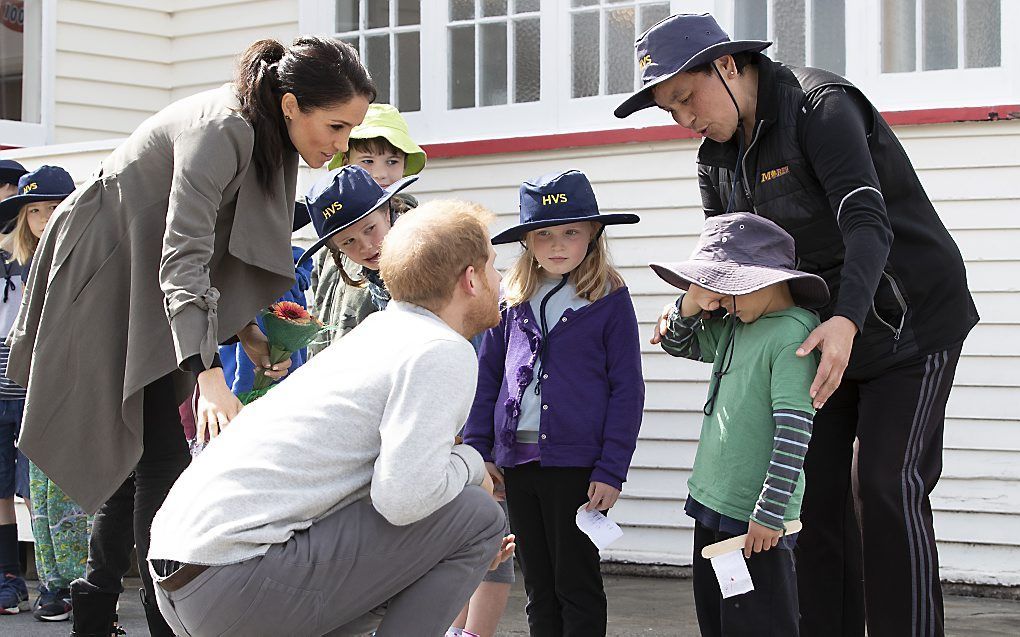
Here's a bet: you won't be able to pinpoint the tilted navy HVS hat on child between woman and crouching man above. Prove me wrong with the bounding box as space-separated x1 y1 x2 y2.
298 166 418 264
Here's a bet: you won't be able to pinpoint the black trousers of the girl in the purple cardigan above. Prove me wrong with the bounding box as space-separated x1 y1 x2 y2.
504 463 607 637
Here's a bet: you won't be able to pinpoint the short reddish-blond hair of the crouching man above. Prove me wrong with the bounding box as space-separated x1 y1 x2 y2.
379 200 494 312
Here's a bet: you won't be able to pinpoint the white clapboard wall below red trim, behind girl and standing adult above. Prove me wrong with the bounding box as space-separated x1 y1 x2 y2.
393 122 1020 585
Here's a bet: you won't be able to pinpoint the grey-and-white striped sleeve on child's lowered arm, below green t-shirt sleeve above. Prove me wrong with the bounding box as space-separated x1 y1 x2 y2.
751 409 814 531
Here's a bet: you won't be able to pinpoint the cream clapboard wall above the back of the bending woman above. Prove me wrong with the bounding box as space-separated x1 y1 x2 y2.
53 0 298 144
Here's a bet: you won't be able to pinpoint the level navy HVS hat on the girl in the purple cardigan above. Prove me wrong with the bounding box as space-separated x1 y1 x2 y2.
493 170 641 246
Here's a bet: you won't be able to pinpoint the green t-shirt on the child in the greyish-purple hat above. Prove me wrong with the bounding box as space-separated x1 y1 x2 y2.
687 307 818 521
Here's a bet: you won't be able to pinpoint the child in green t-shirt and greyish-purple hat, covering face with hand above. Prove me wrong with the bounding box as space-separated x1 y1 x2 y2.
651 213 828 636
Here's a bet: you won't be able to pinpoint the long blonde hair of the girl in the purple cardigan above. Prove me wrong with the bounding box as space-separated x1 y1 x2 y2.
503 226 624 307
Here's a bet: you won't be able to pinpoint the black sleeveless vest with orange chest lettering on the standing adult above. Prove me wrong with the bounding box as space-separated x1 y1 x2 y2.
698 56 978 373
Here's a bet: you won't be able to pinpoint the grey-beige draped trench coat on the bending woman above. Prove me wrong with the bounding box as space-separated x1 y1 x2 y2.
7 85 297 512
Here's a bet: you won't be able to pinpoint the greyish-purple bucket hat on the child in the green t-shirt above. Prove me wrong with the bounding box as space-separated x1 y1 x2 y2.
649 212 829 309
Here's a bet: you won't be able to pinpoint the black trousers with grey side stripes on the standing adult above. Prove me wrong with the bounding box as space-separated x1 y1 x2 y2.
797 346 962 637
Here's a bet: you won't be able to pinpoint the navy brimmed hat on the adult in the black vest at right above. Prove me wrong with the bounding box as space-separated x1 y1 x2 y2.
613 13 772 118
